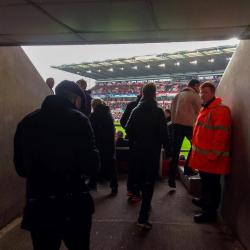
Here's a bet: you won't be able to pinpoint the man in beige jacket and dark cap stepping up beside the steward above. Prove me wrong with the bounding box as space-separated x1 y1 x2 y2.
168 79 202 188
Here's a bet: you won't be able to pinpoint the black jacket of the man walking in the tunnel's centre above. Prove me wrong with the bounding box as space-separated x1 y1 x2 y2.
126 97 172 157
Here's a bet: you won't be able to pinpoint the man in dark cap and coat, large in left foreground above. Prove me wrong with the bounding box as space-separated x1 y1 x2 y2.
14 81 99 250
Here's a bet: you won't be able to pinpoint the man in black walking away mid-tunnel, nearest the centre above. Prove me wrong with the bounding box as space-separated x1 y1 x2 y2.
126 83 172 228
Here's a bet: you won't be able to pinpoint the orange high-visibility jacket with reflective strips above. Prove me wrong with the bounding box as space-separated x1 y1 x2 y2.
189 97 231 174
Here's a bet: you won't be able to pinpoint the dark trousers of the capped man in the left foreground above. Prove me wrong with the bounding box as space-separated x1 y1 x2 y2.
30 216 92 250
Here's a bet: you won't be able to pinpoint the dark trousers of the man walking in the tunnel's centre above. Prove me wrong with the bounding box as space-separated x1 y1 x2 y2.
134 149 161 217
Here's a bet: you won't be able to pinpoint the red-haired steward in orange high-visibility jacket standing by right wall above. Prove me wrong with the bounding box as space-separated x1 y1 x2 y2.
189 82 231 222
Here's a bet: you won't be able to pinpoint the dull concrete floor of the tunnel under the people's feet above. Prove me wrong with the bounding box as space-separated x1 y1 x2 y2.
0 175 242 250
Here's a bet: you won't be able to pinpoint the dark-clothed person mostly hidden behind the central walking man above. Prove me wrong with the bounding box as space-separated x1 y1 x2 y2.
120 86 143 196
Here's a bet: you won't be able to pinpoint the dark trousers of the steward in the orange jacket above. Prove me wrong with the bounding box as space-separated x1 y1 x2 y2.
200 171 221 212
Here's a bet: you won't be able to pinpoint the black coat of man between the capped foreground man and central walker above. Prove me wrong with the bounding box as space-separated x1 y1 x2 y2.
89 104 115 156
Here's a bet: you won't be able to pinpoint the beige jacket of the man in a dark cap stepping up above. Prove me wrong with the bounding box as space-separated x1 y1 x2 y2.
171 87 202 127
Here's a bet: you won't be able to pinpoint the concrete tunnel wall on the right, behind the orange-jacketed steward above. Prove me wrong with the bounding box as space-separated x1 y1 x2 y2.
216 41 250 249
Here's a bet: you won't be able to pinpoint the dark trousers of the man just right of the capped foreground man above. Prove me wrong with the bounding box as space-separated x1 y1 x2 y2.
89 153 118 188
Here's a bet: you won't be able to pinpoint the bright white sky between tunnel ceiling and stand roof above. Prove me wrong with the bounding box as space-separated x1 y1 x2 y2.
22 39 239 88
